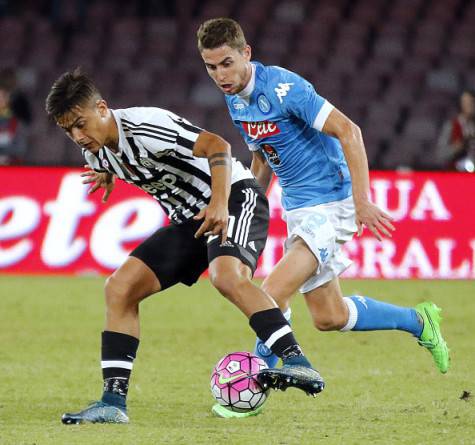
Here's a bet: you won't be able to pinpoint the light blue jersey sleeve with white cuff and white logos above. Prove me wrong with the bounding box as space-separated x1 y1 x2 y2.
275 71 334 131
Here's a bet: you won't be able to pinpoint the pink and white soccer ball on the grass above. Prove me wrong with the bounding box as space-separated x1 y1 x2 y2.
211 352 269 412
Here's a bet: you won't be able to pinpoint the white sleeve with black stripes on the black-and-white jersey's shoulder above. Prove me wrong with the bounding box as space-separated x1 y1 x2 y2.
123 108 203 159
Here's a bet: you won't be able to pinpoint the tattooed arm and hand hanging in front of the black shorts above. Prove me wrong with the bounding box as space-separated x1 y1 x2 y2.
193 131 231 243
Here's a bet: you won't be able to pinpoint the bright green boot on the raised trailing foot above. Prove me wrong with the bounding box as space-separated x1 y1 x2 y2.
415 301 450 374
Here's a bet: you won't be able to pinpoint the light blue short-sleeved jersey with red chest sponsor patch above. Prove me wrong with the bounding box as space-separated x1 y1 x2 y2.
225 62 351 210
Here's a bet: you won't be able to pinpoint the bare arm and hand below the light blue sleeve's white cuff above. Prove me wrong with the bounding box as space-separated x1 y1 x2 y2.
322 108 394 241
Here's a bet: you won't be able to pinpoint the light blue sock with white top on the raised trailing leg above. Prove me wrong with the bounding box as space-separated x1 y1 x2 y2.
342 295 423 338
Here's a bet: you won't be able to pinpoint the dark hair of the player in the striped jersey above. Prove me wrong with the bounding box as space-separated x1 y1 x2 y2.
45 68 102 121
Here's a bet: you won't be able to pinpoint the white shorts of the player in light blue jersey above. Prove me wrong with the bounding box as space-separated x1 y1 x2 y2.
283 196 357 294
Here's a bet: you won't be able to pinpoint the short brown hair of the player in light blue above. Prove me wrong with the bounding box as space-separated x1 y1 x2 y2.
196 17 247 52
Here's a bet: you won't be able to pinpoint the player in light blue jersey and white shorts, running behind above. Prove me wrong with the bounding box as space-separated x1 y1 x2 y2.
197 18 450 416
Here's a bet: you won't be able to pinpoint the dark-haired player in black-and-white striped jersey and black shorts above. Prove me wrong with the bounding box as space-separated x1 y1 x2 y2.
46 70 324 424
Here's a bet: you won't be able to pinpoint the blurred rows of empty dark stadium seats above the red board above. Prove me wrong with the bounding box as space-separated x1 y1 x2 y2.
0 0 475 169
